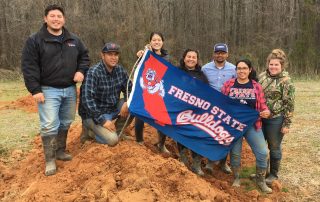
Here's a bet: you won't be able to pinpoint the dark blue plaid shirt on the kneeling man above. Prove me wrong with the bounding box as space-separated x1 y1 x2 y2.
79 61 132 125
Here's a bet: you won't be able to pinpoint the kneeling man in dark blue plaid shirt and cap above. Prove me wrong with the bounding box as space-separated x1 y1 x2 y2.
79 43 132 146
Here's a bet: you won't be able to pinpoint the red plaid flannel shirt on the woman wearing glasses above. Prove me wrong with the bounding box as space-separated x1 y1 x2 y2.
221 78 269 130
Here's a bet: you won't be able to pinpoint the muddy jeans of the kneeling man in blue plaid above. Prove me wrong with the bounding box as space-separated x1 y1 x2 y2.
82 99 133 146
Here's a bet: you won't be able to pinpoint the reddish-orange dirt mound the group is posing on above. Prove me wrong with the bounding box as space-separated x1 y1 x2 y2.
0 96 286 201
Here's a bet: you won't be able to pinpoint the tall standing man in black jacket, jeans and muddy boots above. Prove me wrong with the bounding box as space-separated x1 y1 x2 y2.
21 5 89 176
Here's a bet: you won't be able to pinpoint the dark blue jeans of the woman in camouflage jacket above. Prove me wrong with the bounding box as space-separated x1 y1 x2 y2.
262 116 283 160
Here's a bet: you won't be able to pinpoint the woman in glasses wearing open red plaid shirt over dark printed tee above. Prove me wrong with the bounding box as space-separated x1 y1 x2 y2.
221 59 272 193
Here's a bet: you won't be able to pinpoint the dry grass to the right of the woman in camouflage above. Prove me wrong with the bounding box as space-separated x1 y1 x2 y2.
280 81 320 201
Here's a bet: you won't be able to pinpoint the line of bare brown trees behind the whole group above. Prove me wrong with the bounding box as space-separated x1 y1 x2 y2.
0 0 320 76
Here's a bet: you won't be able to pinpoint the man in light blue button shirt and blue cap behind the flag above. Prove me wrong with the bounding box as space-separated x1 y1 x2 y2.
201 43 236 173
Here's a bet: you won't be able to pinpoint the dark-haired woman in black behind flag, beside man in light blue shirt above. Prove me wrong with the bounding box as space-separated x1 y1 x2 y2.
177 49 209 176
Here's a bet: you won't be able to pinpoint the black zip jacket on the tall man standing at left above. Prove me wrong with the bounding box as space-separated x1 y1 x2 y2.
21 24 89 95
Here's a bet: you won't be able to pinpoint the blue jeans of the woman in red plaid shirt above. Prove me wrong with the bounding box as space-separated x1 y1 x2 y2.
230 126 268 169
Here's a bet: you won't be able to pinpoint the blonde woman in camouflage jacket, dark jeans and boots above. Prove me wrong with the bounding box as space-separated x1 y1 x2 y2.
259 49 295 185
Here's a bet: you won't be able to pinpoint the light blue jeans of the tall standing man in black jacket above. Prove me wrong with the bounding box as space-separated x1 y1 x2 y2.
38 86 77 136
